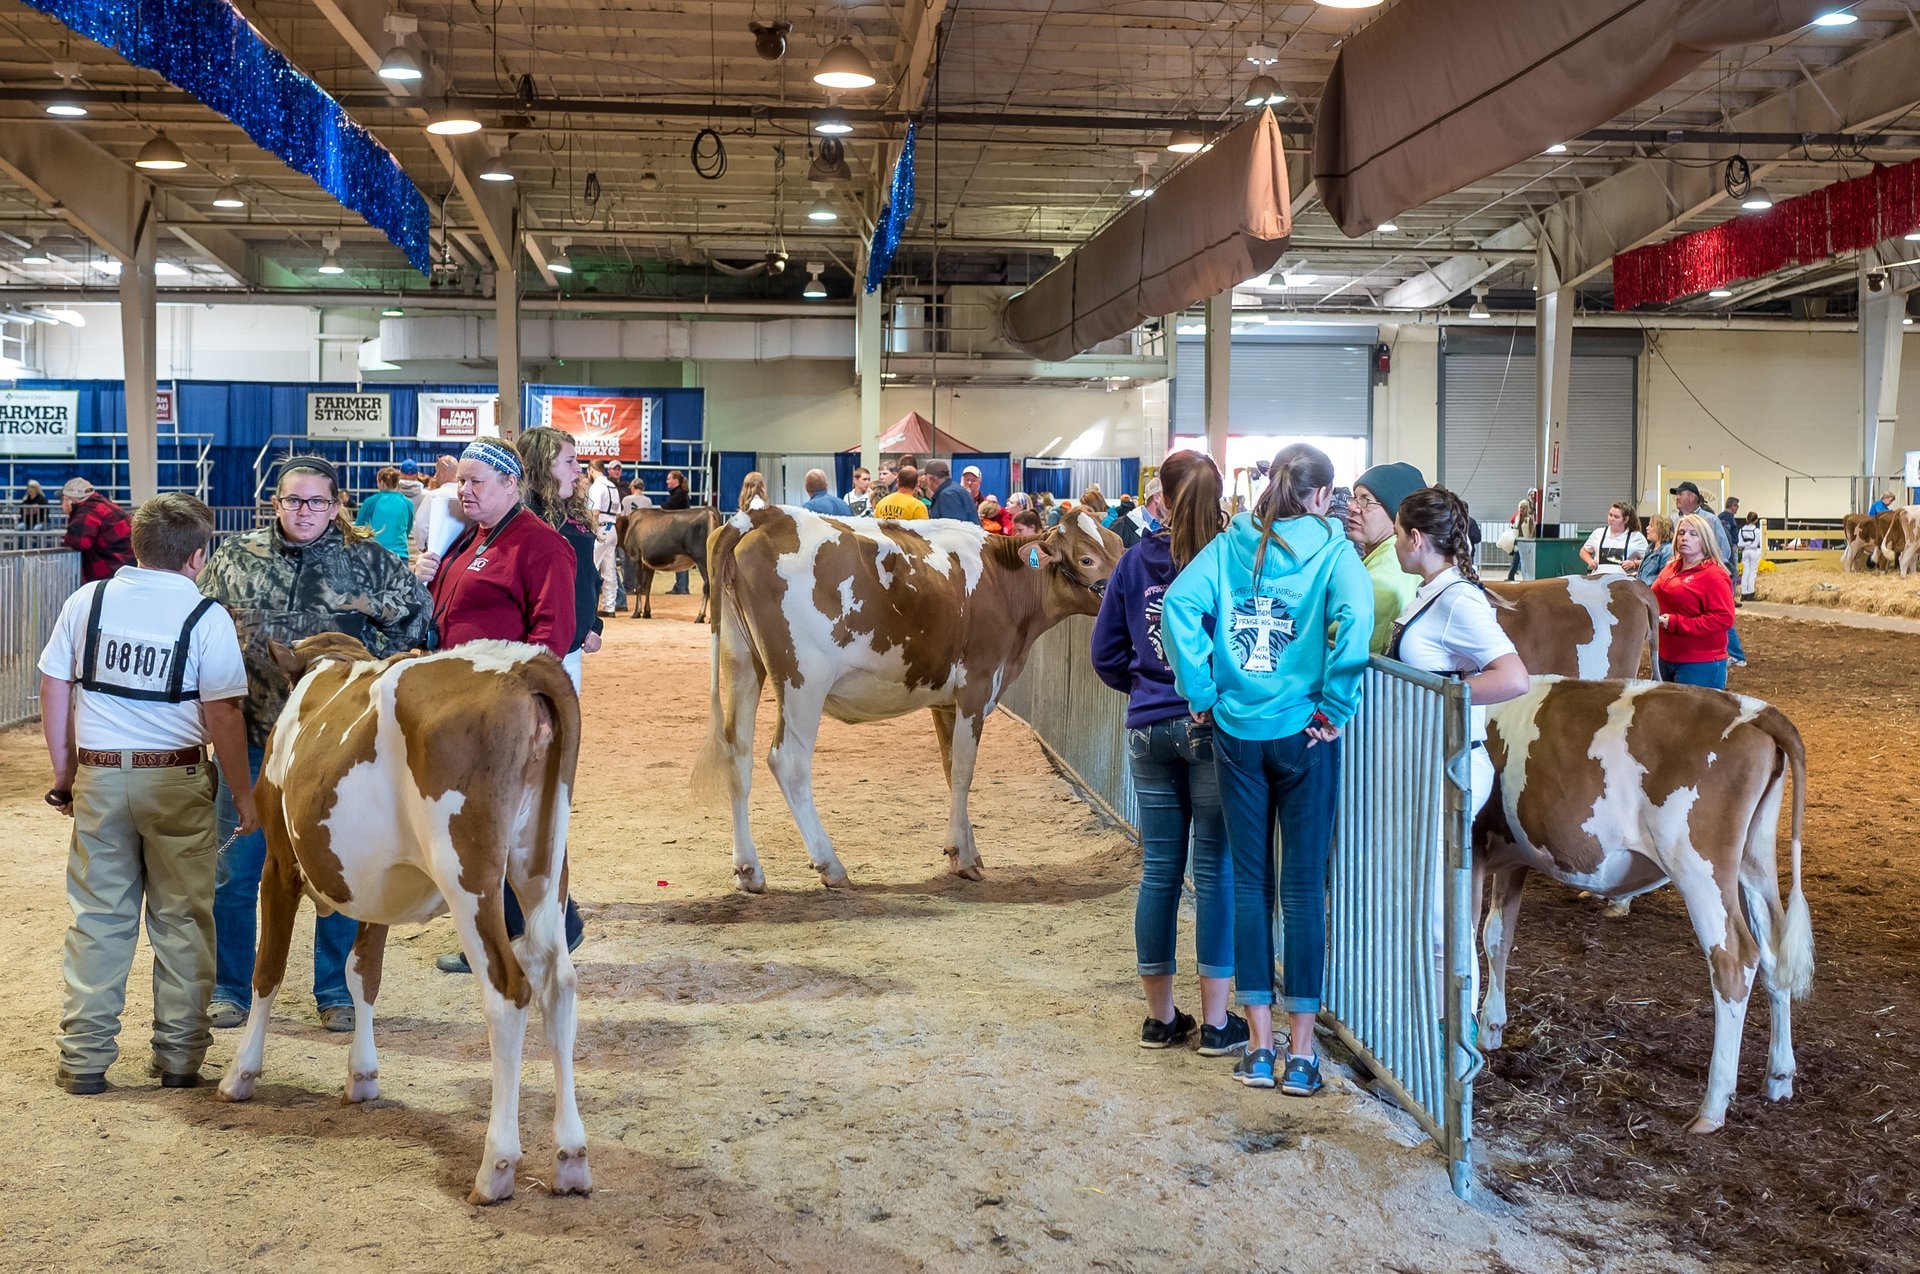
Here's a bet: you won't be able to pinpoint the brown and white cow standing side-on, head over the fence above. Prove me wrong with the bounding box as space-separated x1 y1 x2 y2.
693 507 1121 894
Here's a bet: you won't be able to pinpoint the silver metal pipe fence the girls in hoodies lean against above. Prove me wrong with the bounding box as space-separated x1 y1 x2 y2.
1000 616 1482 1197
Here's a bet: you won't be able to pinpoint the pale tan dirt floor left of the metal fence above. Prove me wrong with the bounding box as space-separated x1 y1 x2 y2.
0 599 1712 1274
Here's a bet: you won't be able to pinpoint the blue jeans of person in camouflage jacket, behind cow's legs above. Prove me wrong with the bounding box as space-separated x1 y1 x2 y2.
213 746 359 1009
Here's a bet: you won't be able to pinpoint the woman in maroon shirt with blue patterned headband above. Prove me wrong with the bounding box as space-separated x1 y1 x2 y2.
413 437 574 658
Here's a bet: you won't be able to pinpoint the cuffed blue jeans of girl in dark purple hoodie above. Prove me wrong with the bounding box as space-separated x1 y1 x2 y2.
1127 718 1233 979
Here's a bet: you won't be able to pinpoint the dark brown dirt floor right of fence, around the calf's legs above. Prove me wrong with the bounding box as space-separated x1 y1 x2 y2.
1475 614 1920 1274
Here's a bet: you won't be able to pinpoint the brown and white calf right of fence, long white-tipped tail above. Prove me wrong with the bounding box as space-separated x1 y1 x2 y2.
1475 677 1812 1132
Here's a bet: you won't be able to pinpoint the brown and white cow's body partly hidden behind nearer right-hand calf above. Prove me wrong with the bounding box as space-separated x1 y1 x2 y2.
1486 576 1659 681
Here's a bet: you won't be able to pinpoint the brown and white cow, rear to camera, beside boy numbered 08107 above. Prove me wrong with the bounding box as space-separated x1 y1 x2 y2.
219 633 591 1203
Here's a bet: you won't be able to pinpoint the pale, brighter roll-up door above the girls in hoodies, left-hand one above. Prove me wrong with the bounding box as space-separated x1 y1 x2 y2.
1173 336 1373 437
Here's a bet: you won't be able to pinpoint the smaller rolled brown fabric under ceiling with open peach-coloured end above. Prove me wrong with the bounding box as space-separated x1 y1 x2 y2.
1000 111 1292 361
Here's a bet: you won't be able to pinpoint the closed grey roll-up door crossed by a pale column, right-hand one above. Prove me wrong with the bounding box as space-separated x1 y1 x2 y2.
1443 342 1638 526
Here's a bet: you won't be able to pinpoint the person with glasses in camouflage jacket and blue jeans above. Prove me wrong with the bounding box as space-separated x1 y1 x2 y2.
200 455 430 1030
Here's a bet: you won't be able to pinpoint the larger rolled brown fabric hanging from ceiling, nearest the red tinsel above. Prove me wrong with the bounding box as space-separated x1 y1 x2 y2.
1313 0 1832 236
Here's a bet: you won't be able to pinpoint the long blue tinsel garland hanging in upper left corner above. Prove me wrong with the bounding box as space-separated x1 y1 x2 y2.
27 0 432 274
